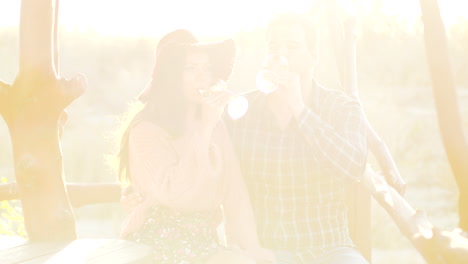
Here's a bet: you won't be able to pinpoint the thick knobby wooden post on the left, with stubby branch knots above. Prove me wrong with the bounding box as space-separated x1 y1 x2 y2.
0 0 85 241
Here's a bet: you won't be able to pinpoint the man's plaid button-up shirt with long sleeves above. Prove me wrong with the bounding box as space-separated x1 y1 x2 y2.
227 84 367 263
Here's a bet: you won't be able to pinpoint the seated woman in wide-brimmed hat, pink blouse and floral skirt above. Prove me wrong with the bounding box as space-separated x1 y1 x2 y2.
114 30 273 264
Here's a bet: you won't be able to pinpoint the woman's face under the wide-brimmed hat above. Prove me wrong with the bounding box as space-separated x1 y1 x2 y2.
182 51 214 104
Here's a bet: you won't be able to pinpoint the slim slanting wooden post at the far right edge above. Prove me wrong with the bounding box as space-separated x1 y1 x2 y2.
420 0 468 231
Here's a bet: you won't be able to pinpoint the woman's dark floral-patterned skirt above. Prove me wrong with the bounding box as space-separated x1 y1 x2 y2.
127 207 225 264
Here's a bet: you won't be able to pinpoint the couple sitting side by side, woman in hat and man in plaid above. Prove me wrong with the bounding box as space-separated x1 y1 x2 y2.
114 13 367 264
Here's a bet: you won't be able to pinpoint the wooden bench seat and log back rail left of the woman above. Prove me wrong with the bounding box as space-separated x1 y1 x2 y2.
0 183 152 264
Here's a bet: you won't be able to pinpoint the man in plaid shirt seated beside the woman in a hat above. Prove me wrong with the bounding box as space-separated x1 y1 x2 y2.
122 13 367 264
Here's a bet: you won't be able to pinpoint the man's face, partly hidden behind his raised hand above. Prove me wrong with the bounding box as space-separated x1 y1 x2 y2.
266 25 314 76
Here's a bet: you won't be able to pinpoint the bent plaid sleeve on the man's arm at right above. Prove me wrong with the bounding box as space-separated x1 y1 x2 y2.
298 94 367 181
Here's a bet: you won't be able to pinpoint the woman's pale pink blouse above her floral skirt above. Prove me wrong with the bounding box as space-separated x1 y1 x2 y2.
129 122 222 210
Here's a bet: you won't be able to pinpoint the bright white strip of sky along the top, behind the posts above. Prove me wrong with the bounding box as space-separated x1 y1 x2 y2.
0 0 468 36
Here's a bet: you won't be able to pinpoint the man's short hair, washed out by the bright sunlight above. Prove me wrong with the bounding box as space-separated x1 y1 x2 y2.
266 12 318 55
